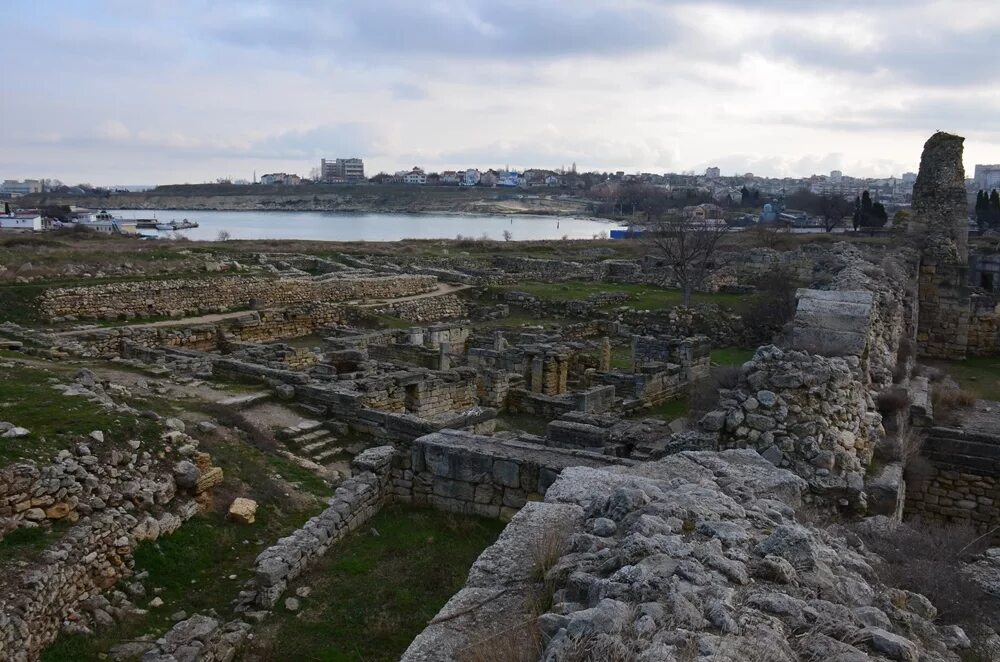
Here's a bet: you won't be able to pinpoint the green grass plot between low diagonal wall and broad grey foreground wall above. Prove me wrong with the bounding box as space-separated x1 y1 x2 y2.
262 506 503 662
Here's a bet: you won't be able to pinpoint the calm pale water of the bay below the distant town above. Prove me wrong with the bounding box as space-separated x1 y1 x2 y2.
111 209 619 241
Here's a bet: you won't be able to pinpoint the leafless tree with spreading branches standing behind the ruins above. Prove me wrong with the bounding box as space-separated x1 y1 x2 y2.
642 216 729 306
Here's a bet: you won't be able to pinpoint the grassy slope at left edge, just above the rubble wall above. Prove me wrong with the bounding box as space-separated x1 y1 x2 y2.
0 365 157 464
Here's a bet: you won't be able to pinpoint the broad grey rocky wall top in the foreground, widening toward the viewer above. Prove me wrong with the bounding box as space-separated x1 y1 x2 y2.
402 451 965 662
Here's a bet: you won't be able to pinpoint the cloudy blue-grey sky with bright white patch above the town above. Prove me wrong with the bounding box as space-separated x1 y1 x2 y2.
0 0 1000 184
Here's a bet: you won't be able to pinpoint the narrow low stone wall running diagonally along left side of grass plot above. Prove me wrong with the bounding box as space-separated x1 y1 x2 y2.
238 446 395 610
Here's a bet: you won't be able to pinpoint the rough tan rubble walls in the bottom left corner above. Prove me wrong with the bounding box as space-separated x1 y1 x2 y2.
0 432 211 661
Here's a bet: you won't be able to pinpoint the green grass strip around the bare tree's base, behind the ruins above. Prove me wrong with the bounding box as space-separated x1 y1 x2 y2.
496 281 749 310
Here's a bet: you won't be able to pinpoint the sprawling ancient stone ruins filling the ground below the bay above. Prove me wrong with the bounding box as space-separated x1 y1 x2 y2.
0 133 1000 662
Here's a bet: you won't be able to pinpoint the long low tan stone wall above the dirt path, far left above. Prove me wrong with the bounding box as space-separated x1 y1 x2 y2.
40 274 437 319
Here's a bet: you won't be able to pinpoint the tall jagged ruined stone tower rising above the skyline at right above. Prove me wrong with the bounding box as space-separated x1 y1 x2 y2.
908 131 970 359
